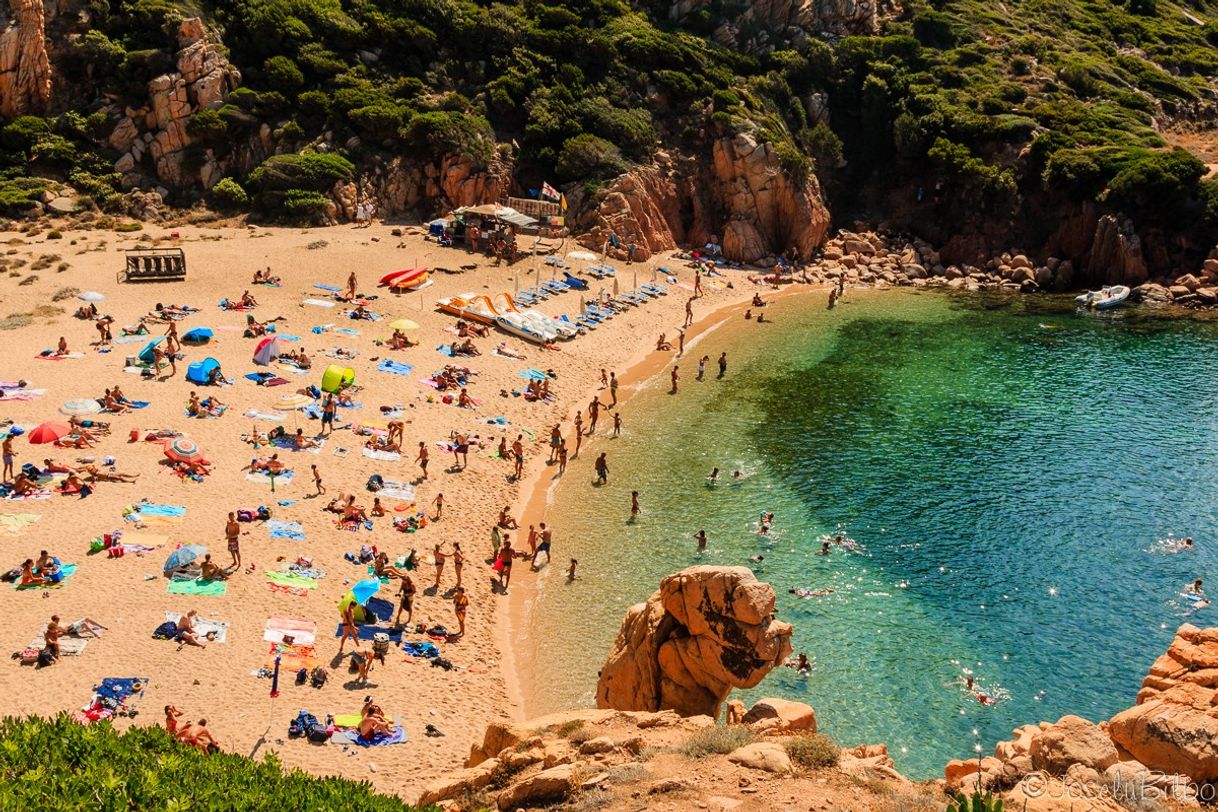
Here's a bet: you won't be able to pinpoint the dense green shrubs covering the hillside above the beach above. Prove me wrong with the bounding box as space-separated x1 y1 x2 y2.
0 0 1218 241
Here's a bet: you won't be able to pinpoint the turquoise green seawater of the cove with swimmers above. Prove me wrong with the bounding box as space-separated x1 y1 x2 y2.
523 291 1218 778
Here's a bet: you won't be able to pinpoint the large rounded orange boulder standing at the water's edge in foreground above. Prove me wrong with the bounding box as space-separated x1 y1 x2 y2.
597 566 790 717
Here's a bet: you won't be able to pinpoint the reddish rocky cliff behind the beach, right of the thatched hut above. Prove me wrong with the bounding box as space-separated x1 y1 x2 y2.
579 134 829 265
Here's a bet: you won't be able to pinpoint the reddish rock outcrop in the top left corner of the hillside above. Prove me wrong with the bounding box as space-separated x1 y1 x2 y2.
0 0 51 118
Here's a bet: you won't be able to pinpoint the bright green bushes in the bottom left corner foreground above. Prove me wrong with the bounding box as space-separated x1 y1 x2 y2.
0 713 421 812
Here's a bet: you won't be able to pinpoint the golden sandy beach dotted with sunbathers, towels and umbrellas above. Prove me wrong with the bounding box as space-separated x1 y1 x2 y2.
0 215 774 799
